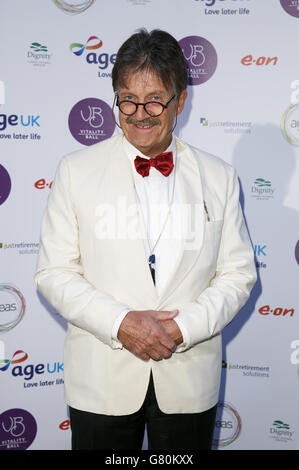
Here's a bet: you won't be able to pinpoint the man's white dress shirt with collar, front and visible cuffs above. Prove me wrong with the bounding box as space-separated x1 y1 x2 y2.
112 137 187 352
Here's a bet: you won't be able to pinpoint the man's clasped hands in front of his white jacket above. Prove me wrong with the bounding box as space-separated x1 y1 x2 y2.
118 310 183 361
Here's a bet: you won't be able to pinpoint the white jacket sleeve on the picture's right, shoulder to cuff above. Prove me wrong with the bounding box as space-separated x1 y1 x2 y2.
177 167 256 352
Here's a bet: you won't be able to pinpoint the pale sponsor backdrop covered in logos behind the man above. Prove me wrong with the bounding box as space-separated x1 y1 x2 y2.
0 0 299 450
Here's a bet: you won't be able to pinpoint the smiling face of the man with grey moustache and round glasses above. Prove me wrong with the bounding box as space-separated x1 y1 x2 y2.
118 71 187 157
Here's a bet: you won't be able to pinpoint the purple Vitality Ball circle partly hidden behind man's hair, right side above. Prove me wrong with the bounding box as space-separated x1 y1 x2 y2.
179 36 217 85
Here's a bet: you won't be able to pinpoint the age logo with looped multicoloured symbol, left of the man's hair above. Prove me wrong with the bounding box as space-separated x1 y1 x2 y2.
69 35 116 78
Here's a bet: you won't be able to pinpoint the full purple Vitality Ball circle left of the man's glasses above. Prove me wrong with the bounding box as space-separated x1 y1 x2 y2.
69 98 115 149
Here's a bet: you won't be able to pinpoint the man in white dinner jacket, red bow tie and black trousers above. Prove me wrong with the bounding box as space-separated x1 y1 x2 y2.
35 30 256 450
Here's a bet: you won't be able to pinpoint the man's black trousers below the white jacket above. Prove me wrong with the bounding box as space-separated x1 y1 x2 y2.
70 376 217 450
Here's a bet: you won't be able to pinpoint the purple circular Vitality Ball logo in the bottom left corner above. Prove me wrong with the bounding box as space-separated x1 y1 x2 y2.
0 408 37 450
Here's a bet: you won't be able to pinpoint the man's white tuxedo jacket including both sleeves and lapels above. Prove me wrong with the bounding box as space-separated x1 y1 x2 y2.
35 136 256 415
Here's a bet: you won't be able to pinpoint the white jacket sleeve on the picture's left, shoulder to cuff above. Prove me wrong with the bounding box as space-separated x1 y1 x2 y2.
34 157 129 347
